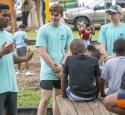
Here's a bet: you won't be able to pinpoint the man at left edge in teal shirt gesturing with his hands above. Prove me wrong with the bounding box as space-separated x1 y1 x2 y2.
0 4 32 115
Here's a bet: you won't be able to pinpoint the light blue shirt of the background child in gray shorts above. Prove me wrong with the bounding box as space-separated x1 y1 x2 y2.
14 31 27 48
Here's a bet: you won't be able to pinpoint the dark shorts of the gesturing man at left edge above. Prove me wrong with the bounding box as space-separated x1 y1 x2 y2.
0 92 17 115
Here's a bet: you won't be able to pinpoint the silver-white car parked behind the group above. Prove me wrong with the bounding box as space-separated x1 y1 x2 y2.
64 0 125 29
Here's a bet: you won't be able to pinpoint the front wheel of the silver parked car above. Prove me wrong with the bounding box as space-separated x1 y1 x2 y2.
74 17 89 30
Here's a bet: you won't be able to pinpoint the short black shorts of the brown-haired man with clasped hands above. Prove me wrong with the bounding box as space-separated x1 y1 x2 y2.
40 80 61 90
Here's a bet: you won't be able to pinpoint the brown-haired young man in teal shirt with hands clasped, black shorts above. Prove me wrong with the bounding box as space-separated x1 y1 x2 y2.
36 4 72 115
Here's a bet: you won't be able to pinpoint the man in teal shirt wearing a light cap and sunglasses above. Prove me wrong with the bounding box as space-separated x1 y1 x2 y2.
98 5 125 61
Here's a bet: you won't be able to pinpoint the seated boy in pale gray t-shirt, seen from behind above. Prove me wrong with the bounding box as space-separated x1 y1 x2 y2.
101 39 125 95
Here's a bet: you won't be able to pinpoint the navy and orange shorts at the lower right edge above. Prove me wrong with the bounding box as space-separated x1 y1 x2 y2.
117 93 125 108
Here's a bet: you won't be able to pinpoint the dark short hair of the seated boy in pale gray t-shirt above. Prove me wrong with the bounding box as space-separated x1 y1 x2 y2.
113 39 125 53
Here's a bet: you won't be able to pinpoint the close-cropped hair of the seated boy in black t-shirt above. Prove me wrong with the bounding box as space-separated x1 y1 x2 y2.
70 39 86 55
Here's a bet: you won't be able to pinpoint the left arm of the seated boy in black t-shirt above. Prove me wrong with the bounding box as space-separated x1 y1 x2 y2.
61 73 68 98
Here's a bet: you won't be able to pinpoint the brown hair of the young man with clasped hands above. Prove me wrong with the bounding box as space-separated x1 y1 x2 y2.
50 4 64 15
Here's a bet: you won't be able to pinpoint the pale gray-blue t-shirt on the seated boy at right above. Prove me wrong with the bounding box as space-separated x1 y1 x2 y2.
101 56 125 95
